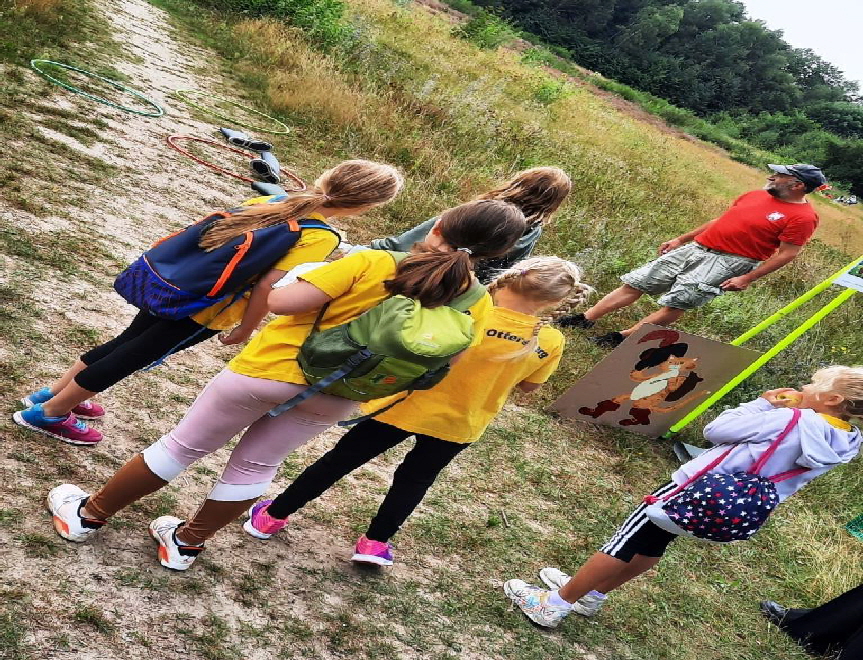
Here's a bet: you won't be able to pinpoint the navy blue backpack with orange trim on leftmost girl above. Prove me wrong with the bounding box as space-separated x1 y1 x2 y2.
114 206 338 320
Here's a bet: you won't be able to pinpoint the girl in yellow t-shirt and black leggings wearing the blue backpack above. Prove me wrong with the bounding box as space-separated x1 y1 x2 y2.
14 160 394 445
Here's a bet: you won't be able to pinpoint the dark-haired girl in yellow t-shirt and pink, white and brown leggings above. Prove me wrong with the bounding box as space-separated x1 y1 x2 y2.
48 200 525 570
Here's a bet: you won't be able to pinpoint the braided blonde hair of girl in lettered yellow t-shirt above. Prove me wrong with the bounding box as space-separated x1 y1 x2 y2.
488 257 594 360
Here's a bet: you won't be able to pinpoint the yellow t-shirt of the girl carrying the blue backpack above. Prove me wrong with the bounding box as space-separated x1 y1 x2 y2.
191 210 339 330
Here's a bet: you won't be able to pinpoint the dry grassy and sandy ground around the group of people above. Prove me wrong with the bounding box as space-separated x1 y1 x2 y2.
0 0 863 660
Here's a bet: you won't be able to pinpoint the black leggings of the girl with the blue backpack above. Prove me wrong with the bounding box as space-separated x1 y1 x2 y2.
75 312 219 392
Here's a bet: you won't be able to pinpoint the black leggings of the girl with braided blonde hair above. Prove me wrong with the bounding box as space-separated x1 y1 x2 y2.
267 419 468 542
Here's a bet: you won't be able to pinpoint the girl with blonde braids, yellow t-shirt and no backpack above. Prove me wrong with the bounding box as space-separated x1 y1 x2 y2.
243 252 591 566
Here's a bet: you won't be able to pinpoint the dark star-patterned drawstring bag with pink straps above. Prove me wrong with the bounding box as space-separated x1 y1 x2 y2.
644 408 809 543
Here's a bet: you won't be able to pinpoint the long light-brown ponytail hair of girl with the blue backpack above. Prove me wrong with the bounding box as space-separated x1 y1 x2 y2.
199 160 404 252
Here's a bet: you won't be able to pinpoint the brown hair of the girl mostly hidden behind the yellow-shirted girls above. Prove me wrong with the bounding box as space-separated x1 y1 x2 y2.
477 167 572 227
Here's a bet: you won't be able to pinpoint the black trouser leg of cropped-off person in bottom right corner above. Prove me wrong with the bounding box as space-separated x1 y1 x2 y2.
782 585 863 660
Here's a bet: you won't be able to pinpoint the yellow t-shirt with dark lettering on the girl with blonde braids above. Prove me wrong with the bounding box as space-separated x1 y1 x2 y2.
362 307 564 442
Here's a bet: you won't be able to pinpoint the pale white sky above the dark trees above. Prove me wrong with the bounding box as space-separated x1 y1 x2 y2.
742 0 863 90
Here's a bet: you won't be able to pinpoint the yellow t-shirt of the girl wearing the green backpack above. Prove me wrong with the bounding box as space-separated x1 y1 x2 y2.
228 250 492 385
